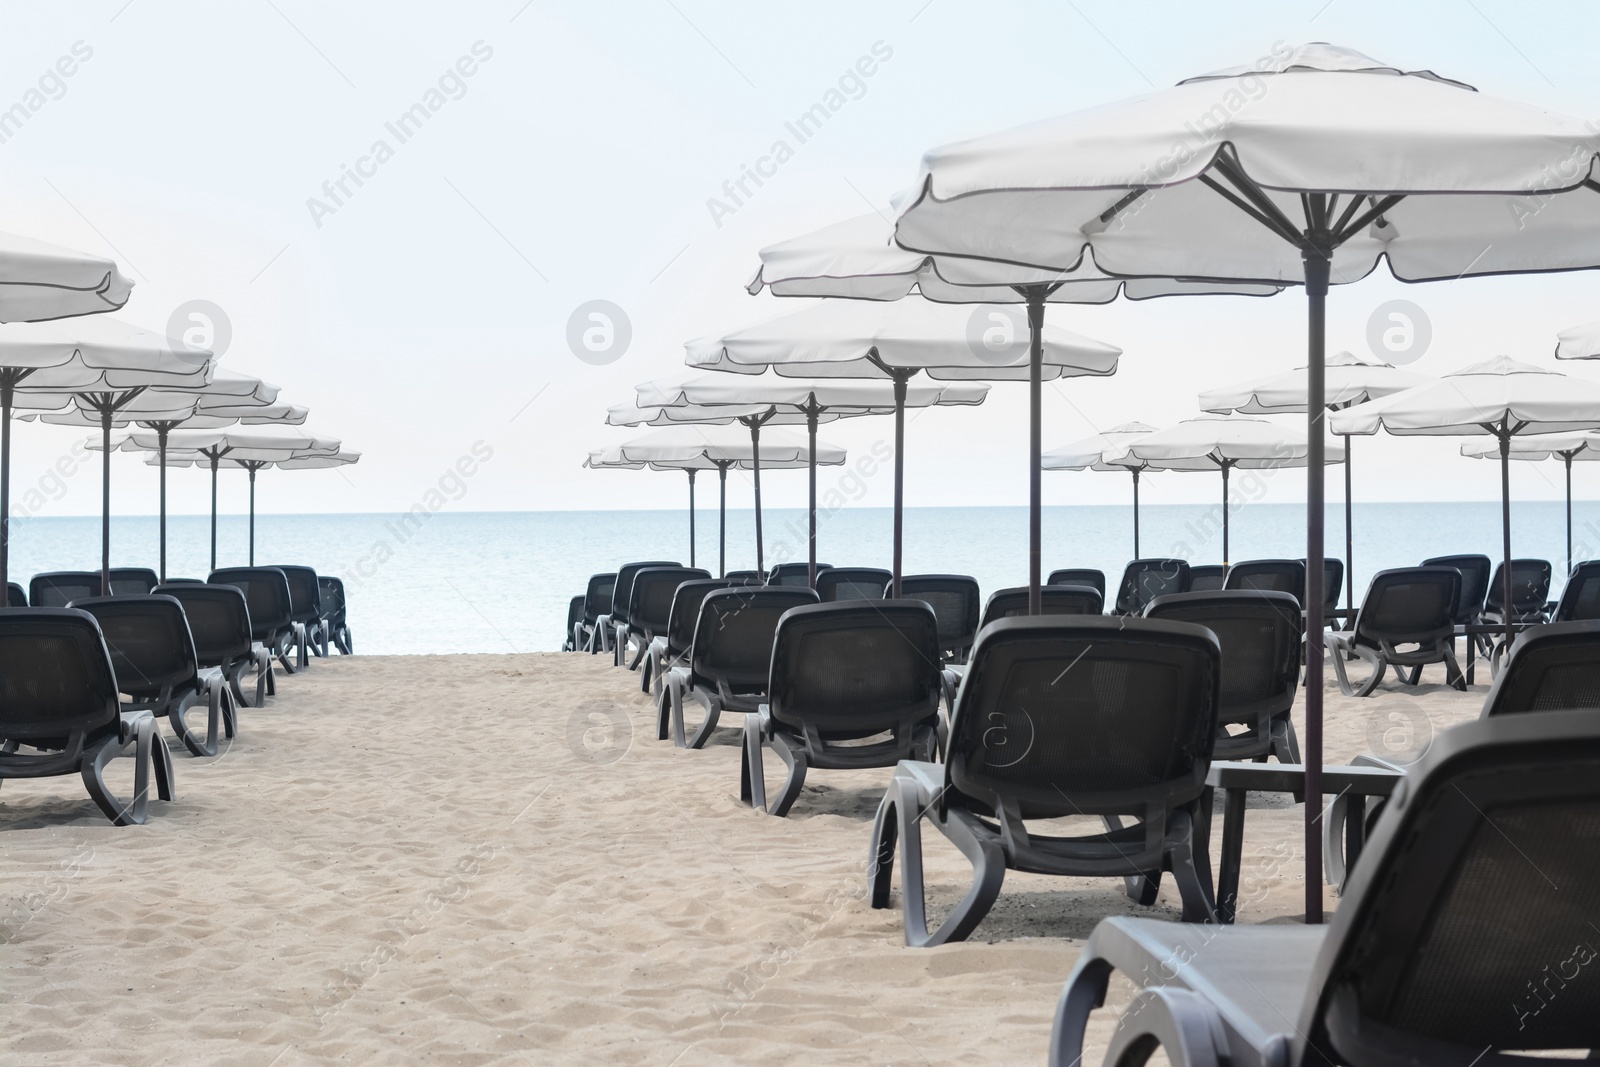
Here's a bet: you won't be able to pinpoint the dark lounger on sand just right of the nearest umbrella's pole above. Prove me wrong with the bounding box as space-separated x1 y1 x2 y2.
1328 566 1467 696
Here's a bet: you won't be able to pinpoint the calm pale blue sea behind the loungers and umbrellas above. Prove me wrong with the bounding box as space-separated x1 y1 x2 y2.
11 501 1600 654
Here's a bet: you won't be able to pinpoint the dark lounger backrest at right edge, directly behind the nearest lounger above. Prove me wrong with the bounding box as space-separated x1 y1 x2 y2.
1483 621 1600 718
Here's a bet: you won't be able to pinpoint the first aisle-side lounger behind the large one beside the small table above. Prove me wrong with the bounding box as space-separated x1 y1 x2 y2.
739 600 944 817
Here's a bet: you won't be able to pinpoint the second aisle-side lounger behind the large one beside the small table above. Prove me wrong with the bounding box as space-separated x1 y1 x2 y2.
656 585 816 749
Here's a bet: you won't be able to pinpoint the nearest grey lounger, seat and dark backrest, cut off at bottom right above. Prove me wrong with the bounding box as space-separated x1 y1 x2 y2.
1050 712 1600 1067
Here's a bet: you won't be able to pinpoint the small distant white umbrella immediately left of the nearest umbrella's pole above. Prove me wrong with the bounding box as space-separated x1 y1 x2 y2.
1106 414 1344 566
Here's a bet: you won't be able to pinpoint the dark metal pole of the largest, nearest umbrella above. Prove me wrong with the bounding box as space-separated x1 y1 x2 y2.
1301 241 1333 923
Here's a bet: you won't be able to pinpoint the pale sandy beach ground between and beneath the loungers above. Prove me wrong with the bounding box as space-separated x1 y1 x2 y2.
0 654 1486 1067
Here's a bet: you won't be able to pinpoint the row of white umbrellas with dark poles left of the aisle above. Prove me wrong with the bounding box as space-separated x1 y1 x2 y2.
0 234 360 589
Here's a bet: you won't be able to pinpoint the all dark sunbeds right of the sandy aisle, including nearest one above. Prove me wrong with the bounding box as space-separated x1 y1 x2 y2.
568 560 1600 1065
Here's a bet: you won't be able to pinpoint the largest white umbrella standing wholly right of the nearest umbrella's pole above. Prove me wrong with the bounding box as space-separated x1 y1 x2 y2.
1331 355 1600 646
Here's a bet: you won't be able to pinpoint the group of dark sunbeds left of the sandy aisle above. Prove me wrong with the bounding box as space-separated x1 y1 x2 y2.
0 565 354 825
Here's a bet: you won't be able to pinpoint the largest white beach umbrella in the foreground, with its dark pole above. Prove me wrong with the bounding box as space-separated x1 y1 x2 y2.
894 43 1600 921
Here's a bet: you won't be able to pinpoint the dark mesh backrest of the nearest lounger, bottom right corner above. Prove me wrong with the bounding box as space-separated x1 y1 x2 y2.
1283 712 1600 1064
